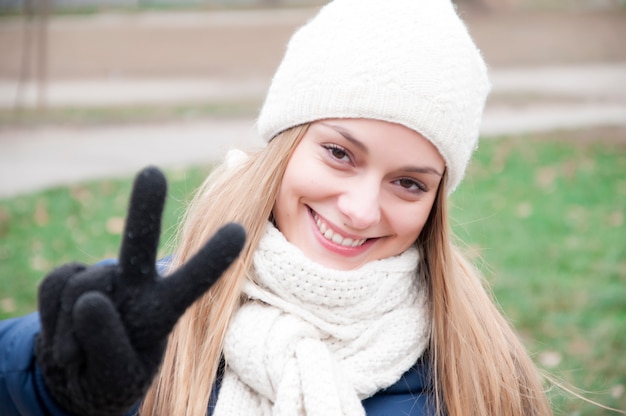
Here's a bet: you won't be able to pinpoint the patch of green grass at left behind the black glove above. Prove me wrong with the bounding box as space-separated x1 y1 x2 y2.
0 167 209 319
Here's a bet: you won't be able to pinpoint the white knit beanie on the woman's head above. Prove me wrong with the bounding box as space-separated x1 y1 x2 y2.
258 0 490 193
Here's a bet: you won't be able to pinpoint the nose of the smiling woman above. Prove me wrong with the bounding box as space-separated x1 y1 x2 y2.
337 178 381 230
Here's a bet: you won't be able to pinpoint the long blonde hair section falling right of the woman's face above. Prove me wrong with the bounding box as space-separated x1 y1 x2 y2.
417 175 552 416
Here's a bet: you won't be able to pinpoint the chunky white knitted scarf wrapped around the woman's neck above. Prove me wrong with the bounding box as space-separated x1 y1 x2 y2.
213 224 429 416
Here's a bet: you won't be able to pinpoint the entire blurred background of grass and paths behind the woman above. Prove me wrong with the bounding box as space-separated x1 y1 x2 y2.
0 0 626 415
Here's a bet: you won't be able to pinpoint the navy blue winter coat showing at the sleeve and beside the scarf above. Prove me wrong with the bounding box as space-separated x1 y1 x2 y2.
0 304 434 416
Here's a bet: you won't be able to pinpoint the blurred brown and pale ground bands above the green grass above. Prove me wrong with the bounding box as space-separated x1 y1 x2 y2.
0 0 626 196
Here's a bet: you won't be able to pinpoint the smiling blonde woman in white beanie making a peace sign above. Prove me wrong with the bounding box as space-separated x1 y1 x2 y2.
0 0 551 416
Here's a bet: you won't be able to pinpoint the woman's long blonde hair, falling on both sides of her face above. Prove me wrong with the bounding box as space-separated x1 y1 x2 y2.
140 126 551 416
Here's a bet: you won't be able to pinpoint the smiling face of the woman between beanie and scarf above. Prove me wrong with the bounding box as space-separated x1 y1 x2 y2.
273 119 445 270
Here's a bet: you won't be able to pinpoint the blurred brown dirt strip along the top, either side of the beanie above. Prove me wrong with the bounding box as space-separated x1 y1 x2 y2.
0 8 626 80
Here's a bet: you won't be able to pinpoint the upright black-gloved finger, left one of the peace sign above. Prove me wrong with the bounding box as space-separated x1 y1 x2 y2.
120 167 167 284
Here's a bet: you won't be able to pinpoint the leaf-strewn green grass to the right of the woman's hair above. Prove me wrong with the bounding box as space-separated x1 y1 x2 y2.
452 137 626 415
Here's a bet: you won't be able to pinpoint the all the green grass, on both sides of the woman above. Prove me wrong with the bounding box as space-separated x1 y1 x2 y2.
0 134 626 416
